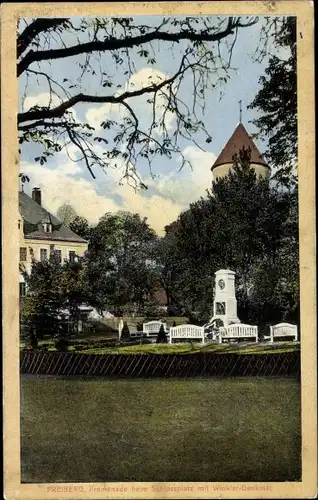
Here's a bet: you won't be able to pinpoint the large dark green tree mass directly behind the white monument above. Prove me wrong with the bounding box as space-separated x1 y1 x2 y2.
161 150 299 323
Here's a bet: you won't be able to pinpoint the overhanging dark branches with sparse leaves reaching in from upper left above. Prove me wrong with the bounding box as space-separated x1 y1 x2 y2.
17 16 258 186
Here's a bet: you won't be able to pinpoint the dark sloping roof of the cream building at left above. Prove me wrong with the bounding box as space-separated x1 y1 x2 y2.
19 192 87 243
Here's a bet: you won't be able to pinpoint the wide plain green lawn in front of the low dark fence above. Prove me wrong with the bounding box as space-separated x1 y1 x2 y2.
21 376 301 482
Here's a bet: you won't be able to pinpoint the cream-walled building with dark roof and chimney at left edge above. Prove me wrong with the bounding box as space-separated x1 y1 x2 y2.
18 188 88 296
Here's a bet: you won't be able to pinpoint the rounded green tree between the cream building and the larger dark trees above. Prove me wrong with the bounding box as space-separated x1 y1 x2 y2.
87 212 157 315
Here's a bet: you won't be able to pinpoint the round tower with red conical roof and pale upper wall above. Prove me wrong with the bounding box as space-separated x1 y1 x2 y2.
211 122 270 181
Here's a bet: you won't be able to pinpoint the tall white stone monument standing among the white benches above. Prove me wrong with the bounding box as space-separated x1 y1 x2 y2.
210 269 240 327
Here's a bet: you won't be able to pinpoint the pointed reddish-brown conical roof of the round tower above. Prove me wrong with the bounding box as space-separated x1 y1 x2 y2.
211 123 269 170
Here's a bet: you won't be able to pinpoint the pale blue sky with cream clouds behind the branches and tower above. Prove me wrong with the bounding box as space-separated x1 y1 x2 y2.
19 16 288 234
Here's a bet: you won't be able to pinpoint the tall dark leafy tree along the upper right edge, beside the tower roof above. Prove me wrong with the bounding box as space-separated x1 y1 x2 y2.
249 17 298 183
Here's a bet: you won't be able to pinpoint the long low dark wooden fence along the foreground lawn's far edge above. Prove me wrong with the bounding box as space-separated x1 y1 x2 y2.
20 351 300 377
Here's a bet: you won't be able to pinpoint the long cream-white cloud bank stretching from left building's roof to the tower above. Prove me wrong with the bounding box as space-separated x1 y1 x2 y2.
21 141 215 235
